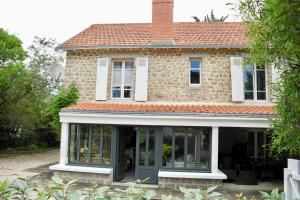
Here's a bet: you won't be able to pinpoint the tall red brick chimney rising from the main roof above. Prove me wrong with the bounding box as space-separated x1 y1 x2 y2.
151 0 174 45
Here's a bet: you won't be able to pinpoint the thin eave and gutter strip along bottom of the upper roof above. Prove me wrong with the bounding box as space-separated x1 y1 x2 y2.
55 44 247 51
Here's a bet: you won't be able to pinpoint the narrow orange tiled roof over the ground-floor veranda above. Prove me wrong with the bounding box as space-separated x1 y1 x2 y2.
63 103 275 115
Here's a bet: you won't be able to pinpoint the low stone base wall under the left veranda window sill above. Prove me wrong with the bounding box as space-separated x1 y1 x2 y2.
54 171 113 185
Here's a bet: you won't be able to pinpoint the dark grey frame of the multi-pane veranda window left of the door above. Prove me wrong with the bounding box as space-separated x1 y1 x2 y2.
67 123 113 167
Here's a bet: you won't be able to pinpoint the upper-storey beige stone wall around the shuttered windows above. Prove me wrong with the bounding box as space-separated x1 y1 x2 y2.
65 49 272 103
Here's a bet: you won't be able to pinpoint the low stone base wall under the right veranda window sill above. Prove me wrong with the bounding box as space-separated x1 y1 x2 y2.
158 178 222 189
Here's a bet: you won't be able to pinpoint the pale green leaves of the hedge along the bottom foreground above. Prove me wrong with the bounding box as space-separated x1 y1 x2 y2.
0 177 284 200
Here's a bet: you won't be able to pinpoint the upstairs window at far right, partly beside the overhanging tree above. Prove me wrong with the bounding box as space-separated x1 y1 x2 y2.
244 65 267 101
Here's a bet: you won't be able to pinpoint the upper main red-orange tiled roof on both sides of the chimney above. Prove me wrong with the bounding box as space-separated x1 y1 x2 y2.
59 22 247 49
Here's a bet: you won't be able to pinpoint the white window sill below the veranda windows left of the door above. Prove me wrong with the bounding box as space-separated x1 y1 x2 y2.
49 164 113 174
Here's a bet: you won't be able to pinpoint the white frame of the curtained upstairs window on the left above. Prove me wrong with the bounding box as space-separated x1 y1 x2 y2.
111 59 134 100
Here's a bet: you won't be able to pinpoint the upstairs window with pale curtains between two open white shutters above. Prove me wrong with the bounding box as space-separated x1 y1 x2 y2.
112 61 133 99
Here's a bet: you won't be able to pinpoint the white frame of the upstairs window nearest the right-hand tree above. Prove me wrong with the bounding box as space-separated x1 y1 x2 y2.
243 64 268 102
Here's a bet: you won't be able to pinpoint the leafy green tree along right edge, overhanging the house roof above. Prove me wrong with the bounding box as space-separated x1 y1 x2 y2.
238 0 300 157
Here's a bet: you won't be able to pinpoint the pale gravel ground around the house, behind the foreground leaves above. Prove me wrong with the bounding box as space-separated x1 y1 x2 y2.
0 149 283 199
